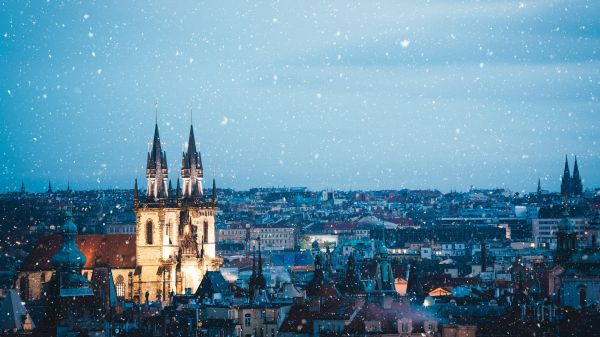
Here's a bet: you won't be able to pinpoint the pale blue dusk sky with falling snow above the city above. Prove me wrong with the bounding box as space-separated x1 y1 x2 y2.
0 0 600 191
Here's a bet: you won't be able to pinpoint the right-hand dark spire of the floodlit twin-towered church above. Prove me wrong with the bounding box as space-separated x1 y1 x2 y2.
181 125 204 199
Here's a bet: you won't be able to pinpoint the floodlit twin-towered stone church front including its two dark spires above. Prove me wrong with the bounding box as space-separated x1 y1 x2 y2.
133 117 221 303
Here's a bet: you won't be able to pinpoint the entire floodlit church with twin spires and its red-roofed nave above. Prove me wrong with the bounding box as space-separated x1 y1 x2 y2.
15 119 222 303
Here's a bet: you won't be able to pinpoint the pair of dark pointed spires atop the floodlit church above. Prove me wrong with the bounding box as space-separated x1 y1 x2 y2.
134 109 216 201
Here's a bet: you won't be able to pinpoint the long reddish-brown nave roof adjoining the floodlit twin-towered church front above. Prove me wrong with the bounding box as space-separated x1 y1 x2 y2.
21 234 135 271
